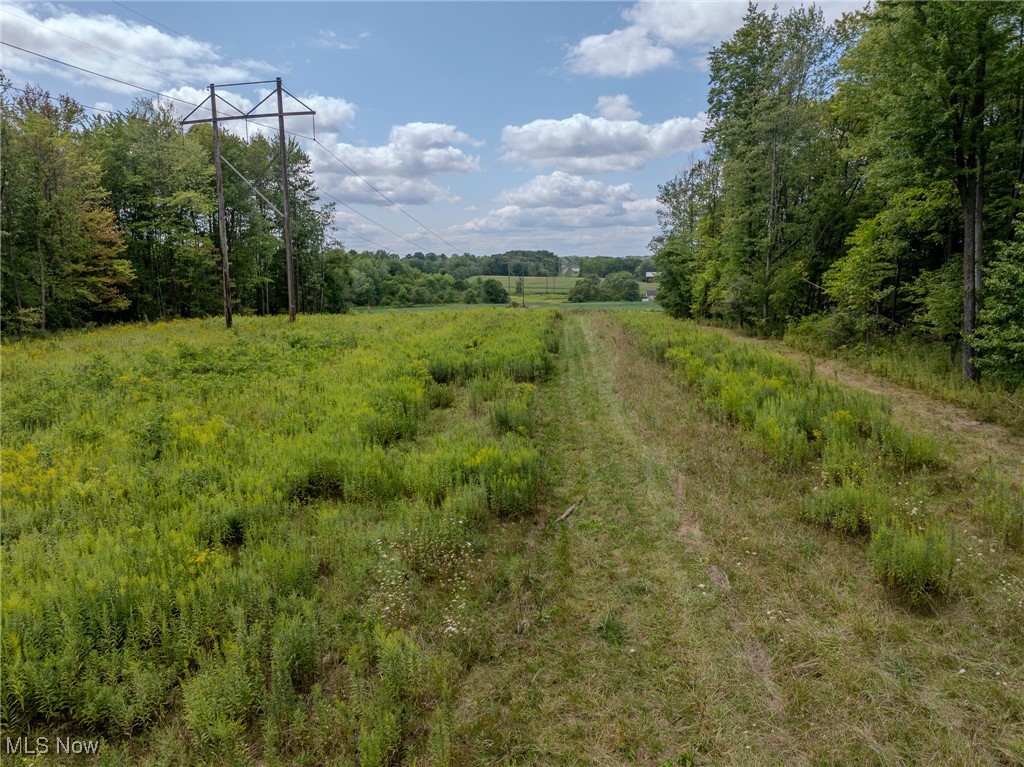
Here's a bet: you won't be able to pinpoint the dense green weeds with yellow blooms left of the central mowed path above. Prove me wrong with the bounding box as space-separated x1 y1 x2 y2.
2 311 560 765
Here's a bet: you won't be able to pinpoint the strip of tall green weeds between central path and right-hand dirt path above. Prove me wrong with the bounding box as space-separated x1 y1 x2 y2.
620 314 954 602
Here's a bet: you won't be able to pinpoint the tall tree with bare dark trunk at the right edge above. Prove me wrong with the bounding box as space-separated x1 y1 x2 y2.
844 0 1024 379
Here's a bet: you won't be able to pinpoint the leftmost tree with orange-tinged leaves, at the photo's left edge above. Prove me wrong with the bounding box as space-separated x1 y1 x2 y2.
0 80 134 330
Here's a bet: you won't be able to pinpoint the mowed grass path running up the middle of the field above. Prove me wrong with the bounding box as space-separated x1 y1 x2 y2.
454 313 1024 765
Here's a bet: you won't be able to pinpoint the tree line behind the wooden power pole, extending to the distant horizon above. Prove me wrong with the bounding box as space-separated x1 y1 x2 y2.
0 73 649 333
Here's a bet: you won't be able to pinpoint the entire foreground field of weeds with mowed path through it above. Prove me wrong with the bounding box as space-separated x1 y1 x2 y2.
0 308 1024 767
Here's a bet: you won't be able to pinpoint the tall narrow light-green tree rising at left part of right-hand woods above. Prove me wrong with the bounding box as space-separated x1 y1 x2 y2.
704 4 840 328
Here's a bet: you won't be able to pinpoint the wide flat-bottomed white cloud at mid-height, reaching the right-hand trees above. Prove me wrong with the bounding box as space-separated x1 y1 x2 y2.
502 113 706 173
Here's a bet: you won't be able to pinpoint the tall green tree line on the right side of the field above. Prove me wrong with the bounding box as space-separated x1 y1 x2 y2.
651 0 1024 383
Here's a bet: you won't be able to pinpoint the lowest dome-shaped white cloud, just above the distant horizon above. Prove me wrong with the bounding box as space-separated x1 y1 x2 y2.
454 171 657 236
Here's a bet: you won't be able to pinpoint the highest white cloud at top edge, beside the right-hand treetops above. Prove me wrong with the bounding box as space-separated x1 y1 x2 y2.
565 0 863 77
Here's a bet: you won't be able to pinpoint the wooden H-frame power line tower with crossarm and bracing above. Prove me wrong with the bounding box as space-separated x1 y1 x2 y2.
181 77 316 328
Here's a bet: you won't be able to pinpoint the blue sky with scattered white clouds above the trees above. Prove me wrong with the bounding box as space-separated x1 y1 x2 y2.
0 0 862 256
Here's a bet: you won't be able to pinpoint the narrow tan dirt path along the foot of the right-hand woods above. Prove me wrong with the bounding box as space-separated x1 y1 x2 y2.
708 328 1024 484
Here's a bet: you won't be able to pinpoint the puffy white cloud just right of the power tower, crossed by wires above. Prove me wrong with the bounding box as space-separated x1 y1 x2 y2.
310 123 480 205
